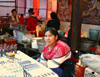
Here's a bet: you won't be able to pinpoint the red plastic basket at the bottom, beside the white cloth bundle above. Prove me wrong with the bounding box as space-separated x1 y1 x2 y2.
75 64 86 77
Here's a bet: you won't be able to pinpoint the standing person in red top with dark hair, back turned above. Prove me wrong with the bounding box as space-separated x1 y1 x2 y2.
27 8 38 34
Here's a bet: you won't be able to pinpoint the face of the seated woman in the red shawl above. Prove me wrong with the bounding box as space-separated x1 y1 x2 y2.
44 31 58 47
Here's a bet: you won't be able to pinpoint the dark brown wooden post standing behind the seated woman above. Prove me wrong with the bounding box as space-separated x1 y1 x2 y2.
71 0 83 58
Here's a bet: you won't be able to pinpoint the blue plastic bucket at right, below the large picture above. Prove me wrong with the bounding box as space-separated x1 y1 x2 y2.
89 29 99 40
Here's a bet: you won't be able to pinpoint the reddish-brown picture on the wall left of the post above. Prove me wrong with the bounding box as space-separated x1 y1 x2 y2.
57 0 72 22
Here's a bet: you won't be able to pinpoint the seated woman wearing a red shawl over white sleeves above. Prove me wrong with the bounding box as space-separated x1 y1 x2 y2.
40 28 76 77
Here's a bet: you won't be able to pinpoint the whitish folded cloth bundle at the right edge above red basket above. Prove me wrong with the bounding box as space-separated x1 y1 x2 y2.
79 54 100 74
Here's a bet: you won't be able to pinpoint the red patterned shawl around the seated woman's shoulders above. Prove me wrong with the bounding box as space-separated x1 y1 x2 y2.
43 40 70 60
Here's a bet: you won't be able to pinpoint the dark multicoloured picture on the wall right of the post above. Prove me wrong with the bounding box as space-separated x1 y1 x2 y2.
82 0 100 25
